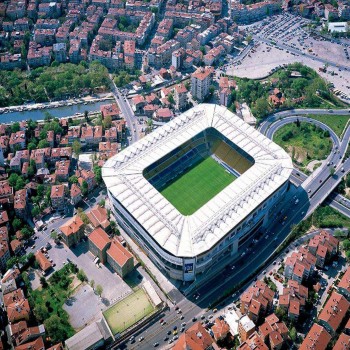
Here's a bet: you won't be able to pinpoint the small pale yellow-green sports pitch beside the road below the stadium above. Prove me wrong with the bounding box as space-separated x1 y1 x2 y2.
103 288 154 334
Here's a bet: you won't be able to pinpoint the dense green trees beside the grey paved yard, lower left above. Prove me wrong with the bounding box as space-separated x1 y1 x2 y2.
23 264 76 343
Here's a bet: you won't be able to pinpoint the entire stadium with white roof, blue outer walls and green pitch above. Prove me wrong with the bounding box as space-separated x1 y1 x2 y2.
102 104 293 281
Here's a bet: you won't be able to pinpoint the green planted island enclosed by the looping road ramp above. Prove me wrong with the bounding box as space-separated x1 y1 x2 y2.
273 122 332 167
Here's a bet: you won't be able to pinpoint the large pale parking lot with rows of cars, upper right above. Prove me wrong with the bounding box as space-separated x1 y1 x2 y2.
225 13 350 101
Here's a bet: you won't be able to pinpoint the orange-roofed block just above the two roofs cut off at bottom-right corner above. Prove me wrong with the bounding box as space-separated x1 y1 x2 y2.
318 292 350 335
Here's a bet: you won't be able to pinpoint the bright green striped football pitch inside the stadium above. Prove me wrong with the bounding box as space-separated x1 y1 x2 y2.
161 157 236 215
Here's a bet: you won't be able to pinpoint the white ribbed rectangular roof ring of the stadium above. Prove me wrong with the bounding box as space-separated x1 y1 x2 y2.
102 104 293 257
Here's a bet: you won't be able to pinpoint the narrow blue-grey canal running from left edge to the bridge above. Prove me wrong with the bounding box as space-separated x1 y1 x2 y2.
0 100 113 123
